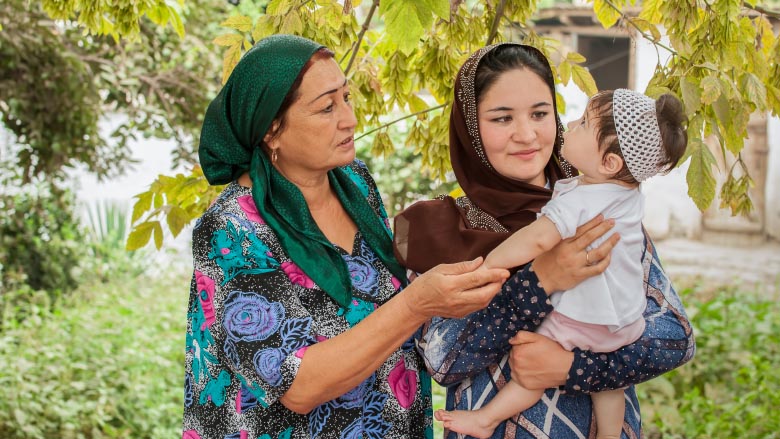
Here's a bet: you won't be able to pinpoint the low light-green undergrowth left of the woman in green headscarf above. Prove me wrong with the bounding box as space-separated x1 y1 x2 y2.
0 271 189 439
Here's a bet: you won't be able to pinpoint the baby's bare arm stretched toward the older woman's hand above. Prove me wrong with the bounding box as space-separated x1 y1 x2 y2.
483 216 561 268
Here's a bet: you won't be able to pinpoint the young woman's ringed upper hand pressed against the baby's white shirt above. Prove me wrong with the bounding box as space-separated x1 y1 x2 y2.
532 215 620 294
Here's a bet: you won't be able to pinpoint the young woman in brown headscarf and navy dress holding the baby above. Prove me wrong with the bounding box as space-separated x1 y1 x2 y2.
395 43 694 439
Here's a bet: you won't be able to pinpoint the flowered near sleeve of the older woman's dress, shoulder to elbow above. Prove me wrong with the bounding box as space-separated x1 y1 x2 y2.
187 188 316 412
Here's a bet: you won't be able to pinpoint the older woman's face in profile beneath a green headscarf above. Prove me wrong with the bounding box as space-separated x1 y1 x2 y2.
266 58 357 176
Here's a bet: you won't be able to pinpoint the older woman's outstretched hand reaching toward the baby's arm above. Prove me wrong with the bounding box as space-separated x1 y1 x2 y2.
403 257 509 320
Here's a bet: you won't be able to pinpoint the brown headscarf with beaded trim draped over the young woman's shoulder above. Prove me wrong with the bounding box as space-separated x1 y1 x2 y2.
394 43 574 272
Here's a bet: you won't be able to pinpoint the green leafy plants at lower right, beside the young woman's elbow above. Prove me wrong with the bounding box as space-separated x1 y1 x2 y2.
639 288 780 438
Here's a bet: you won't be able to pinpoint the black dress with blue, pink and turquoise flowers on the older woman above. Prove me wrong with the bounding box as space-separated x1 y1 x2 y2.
182 161 433 439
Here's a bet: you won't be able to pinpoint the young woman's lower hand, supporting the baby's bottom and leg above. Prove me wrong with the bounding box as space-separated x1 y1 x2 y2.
509 331 574 390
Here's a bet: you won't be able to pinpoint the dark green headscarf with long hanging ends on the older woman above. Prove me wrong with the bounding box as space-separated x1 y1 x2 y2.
198 35 408 307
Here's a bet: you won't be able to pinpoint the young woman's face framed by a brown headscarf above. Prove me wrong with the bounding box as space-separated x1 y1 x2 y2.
477 69 557 186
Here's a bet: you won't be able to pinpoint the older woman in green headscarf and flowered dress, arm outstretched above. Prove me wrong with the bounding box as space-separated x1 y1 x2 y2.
183 35 508 439
